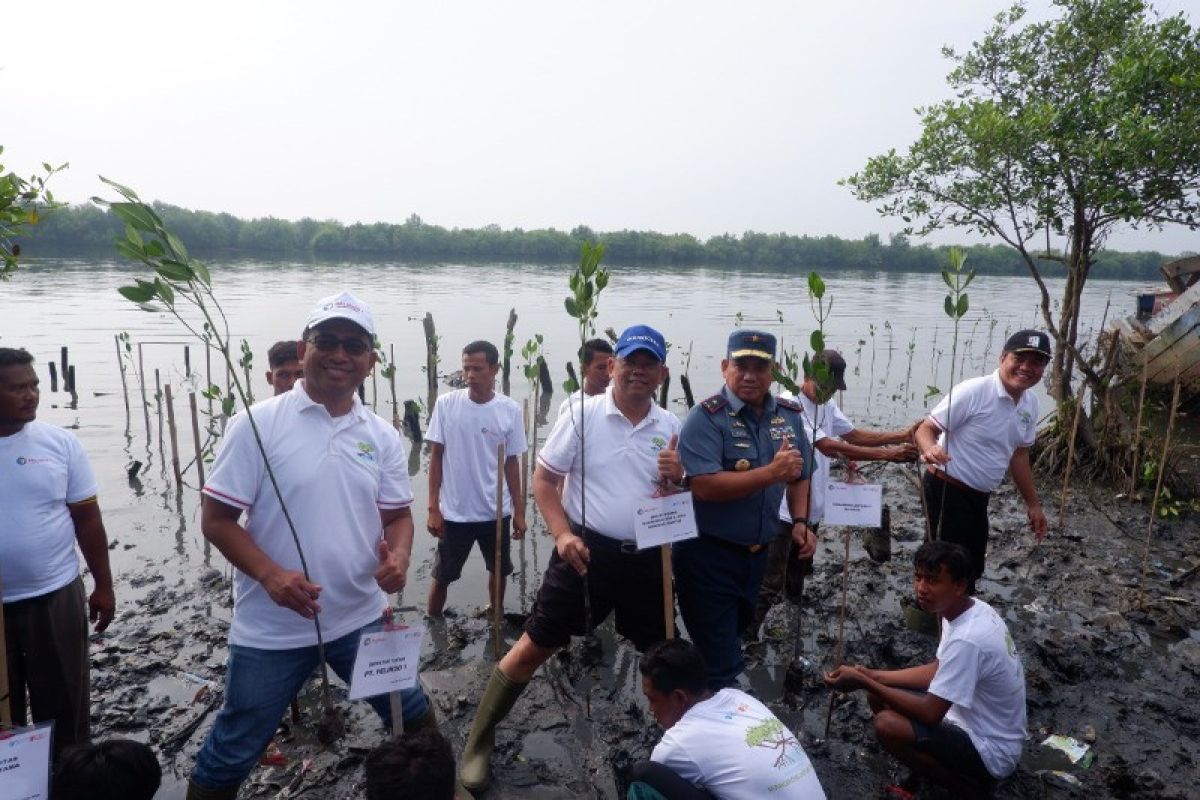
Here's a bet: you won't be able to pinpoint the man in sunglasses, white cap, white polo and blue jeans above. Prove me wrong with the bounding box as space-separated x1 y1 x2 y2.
187 293 436 800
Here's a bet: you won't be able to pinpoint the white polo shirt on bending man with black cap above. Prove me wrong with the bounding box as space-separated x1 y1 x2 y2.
929 369 1038 492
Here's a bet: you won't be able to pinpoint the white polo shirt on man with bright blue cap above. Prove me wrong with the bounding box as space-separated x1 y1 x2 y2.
538 387 683 541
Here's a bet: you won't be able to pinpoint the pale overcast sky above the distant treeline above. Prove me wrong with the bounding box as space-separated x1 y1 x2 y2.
0 0 1200 252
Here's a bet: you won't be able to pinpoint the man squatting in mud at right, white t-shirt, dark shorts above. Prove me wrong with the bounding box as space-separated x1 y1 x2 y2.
826 540 1025 798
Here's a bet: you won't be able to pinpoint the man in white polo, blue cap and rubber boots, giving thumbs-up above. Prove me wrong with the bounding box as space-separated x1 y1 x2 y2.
460 325 683 792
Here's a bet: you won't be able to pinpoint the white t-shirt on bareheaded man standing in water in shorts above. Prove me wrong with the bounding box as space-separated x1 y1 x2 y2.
425 389 526 522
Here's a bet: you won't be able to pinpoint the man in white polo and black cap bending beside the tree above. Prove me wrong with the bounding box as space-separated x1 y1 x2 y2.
916 330 1051 593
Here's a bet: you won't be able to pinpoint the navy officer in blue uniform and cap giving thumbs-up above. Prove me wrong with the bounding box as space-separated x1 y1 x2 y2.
673 330 816 690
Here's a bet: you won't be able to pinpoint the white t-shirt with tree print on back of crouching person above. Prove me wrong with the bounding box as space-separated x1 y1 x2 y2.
650 688 826 800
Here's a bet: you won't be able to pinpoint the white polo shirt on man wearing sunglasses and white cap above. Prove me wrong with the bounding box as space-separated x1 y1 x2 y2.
204 380 413 650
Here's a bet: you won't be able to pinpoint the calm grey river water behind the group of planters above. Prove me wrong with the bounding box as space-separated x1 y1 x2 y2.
0 259 1139 608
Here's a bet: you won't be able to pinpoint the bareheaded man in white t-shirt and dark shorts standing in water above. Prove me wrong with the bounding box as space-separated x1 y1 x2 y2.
425 341 526 616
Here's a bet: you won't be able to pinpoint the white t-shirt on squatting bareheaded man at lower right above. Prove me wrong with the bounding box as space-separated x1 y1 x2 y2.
929 600 1025 777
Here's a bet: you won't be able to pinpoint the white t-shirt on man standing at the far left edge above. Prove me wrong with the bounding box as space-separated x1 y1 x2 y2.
0 420 96 603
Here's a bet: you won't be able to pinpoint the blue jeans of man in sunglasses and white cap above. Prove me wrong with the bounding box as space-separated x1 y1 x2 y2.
192 622 428 789
